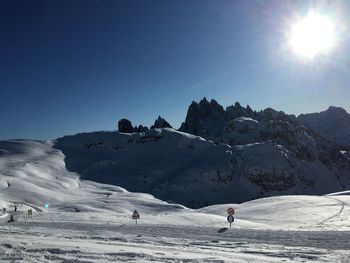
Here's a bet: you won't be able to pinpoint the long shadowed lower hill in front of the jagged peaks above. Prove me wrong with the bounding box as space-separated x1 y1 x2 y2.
54 128 350 208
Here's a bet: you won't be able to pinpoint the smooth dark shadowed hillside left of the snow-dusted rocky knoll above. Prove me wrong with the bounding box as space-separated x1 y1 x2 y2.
55 128 238 207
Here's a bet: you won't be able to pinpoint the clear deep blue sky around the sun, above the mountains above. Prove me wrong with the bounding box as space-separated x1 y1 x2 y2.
0 0 350 139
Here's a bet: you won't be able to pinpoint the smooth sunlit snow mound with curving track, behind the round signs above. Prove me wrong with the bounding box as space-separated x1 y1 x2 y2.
198 191 350 231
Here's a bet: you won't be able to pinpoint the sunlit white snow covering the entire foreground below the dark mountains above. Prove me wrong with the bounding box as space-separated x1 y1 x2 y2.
0 140 350 262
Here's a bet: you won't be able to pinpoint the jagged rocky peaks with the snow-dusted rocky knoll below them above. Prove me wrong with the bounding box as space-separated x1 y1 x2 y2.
176 98 350 202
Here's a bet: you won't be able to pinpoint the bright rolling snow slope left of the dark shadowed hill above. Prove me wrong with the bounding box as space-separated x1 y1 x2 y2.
0 140 184 217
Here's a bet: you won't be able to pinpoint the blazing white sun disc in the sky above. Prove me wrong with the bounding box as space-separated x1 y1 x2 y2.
289 12 335 59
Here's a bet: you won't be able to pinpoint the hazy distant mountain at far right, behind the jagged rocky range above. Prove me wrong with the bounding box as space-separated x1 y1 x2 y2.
298 106 350 147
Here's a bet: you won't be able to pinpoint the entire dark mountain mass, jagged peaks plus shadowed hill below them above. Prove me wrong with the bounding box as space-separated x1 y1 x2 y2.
50 98 350 207
